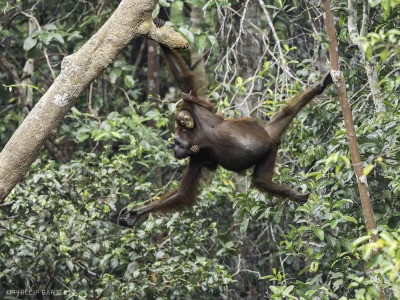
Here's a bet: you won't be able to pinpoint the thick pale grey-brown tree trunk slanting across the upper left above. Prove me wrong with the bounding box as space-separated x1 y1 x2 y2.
0 0 188 203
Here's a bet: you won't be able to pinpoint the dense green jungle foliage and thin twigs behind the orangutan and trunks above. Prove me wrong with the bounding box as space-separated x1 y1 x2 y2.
0 0 400 300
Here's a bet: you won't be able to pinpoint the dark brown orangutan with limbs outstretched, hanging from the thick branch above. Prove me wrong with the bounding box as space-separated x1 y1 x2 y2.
120 22 332 226
